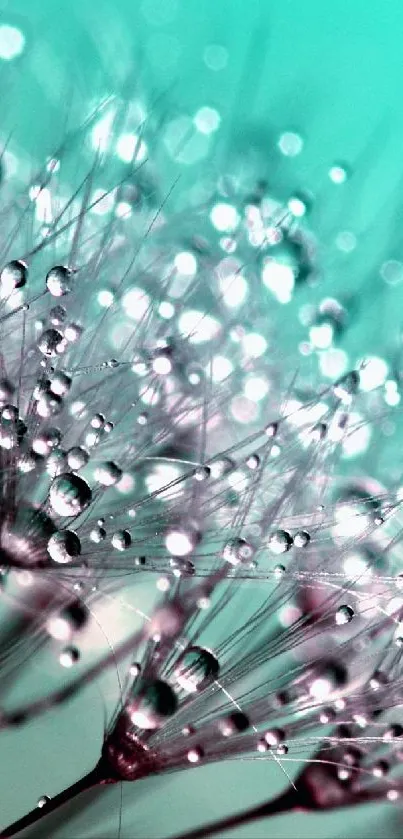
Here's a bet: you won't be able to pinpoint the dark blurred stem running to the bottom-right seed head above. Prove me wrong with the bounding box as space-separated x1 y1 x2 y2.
170 787 301 839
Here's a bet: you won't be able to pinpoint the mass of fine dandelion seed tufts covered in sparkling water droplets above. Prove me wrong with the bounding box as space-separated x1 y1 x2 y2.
0 92 403 839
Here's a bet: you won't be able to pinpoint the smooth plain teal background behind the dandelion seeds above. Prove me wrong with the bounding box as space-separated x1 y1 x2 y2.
0 0 403 839
